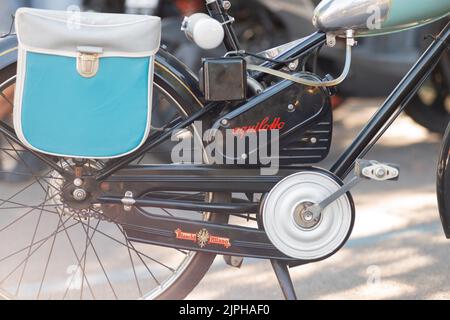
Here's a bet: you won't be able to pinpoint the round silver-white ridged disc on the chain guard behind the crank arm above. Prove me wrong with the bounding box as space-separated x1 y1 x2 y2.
262 170 354 261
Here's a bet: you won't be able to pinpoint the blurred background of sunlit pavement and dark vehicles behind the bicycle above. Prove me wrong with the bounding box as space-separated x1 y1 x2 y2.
0 0 450 299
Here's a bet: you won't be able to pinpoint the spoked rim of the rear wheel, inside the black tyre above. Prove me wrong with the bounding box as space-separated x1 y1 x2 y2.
0 75 212 299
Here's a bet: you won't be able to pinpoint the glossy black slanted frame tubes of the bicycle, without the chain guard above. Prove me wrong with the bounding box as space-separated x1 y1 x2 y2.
0 23 450 187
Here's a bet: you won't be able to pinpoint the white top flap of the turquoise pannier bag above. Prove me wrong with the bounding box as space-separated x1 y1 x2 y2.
16 8 161 57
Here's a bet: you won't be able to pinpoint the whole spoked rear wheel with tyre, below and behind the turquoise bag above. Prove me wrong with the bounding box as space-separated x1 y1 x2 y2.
0 58 229 299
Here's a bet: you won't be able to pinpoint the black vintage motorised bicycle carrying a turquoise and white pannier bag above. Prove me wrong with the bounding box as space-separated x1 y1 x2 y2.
0 0 450 299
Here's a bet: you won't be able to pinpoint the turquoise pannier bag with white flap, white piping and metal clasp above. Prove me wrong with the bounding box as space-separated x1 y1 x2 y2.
14 8 161 159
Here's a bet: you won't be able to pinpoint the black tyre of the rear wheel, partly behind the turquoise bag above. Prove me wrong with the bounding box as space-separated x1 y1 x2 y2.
0 53 231 300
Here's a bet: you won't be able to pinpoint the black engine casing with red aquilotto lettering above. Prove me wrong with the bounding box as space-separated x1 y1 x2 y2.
213 73 333 165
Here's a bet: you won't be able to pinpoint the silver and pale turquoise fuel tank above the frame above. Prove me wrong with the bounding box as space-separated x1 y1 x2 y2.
313 0 450 36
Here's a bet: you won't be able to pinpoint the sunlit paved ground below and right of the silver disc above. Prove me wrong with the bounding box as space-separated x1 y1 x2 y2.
189 100 450 300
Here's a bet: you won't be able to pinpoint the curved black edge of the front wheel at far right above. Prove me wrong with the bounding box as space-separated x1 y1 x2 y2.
437 123 450 239
